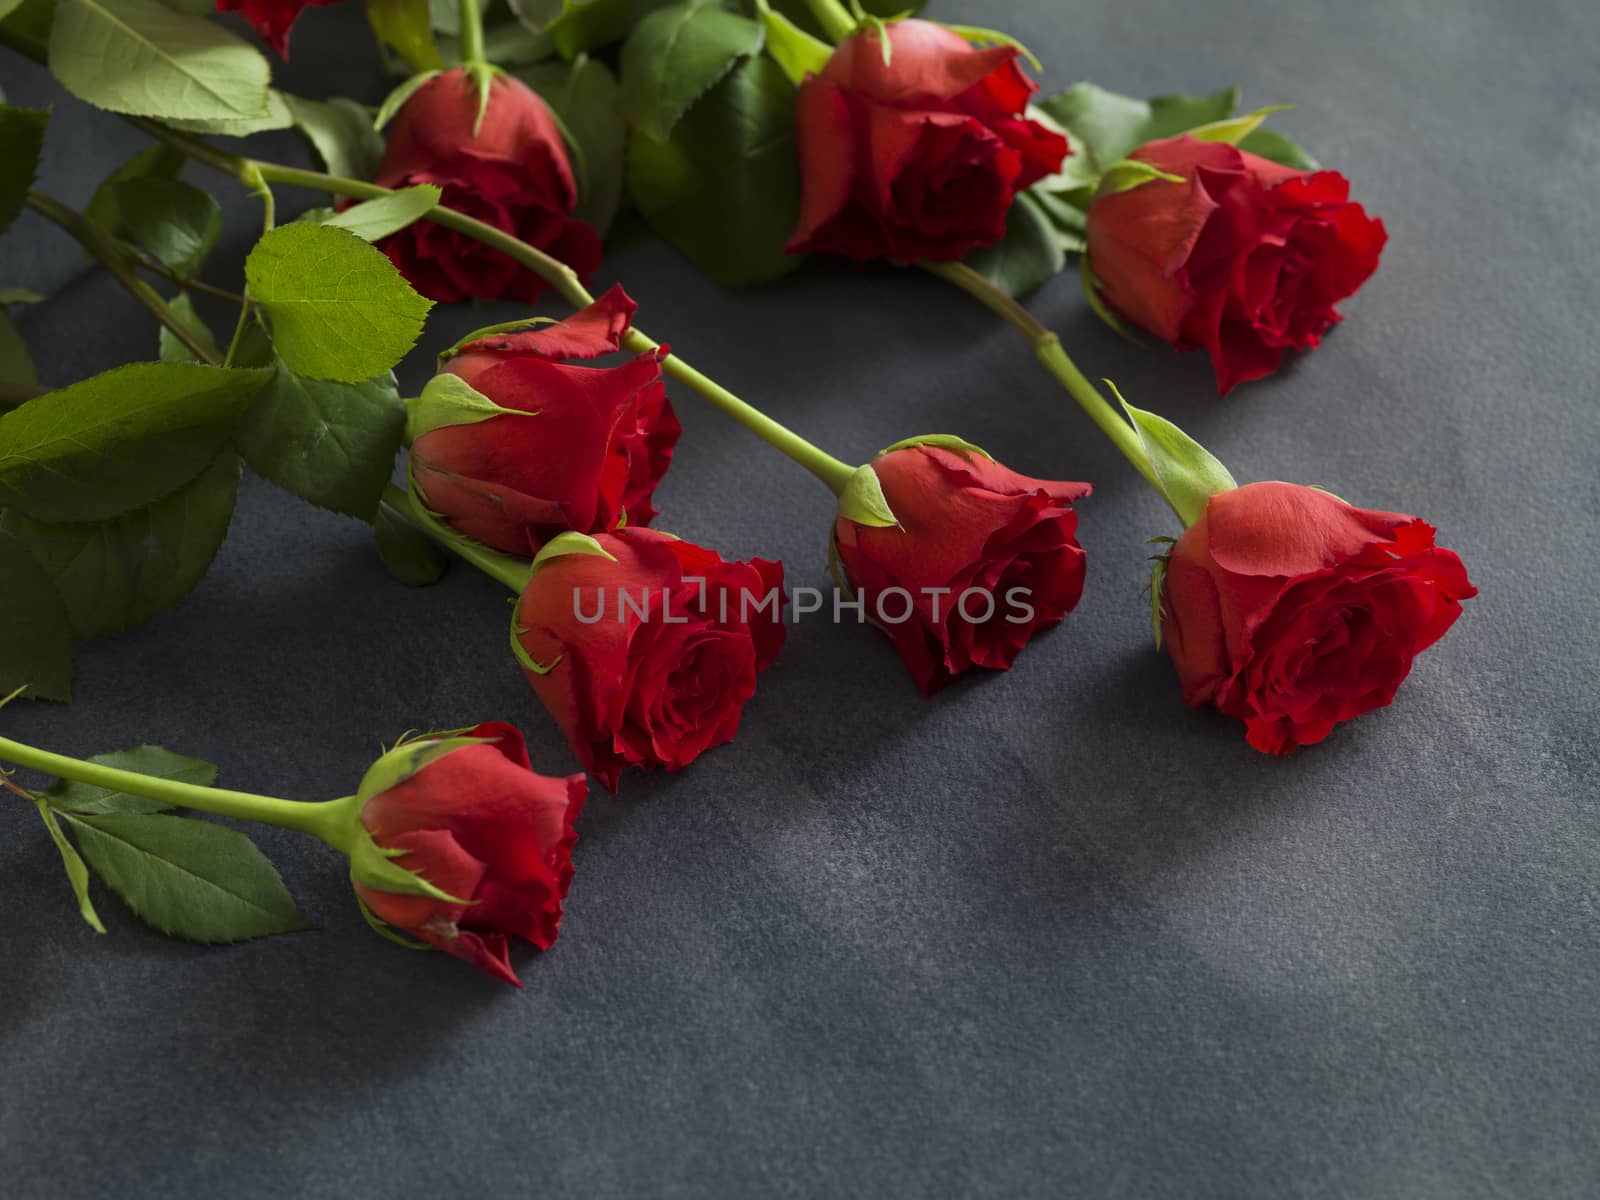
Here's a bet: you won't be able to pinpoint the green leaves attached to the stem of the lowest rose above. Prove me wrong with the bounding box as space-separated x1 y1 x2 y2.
29 746 310 944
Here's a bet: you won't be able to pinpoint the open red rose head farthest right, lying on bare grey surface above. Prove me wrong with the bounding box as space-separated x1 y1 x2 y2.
1162 483 1478 754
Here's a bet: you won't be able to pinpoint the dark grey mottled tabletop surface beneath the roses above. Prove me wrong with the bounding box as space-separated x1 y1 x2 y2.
0 0 1600 1200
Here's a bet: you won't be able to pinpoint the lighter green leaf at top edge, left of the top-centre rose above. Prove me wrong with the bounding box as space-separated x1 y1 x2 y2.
621 0 766 141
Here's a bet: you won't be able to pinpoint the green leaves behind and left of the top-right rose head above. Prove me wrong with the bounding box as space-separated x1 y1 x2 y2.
966 83 1317 299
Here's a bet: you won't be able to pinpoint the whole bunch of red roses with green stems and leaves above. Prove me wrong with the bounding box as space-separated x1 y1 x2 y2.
0 0 1474 982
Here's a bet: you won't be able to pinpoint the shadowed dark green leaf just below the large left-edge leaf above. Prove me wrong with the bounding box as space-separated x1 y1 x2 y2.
0 454 240 637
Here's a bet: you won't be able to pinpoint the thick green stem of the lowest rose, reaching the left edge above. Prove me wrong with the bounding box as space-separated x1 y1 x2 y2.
0 738 354 853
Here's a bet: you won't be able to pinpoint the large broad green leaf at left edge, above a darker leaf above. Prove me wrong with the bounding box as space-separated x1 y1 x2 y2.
0 360 268 522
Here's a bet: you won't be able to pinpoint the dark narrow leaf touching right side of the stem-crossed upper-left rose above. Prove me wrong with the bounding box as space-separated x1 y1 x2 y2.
517 54 627 237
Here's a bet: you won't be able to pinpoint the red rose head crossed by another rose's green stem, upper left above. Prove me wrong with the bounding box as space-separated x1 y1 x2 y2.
378 67 600 302
